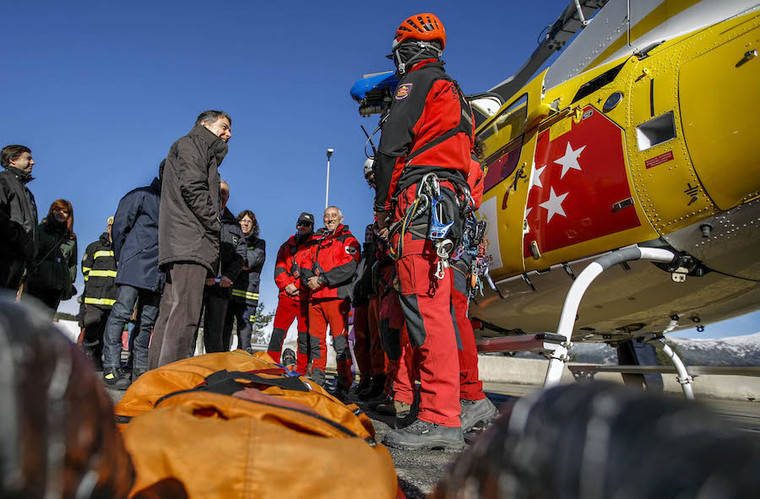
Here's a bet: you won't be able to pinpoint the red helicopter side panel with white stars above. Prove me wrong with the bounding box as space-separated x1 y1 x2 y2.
523 106 641 257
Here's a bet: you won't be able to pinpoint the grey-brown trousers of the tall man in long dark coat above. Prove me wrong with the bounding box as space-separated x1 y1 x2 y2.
148 263 208 369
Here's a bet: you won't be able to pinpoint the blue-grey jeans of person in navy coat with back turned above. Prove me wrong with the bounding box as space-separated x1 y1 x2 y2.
103 285 161 371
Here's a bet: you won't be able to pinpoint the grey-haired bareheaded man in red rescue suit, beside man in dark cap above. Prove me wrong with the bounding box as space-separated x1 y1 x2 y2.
301 206 361 396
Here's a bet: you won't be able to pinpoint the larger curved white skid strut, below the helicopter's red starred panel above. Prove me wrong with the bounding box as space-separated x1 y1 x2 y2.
544 246 677 388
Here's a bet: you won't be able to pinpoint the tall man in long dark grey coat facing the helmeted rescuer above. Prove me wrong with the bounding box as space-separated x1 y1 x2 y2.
149 111 232 369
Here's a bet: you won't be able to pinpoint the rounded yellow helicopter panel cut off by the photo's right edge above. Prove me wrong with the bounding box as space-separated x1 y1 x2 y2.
678 16 760 210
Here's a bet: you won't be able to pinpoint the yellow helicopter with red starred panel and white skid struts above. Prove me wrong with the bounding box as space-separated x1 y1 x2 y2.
352 0 760 388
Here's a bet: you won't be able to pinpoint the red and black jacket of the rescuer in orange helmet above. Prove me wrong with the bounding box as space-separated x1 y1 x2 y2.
375 59 474 211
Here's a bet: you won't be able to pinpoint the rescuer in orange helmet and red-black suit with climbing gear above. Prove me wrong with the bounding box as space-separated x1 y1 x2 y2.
374 14 473 450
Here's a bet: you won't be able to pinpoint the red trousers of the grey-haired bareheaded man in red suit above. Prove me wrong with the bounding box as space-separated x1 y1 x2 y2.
309 298 354 388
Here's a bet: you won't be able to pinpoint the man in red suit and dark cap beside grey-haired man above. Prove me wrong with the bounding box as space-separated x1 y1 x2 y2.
267 212 314 375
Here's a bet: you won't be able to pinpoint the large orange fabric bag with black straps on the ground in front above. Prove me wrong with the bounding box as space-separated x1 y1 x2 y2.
115 350 400 498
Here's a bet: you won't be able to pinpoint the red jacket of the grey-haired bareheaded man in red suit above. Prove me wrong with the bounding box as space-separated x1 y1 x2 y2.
300 224 361 300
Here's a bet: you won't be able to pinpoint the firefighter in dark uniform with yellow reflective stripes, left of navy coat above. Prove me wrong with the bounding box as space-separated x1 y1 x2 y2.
80 217 116 370
